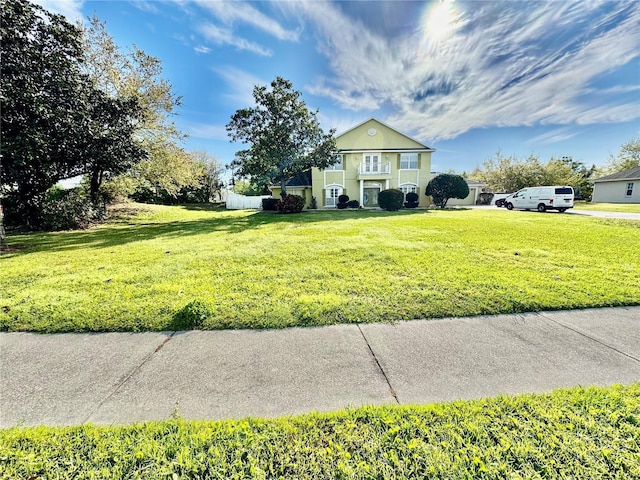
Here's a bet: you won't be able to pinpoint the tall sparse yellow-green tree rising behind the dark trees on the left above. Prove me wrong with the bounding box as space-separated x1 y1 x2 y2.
82 15 188 202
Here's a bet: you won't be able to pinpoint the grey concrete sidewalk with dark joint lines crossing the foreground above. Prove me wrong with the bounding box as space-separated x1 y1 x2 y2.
0 307 640 428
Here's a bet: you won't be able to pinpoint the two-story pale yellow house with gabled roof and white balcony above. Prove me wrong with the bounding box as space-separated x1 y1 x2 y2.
272 118 435 208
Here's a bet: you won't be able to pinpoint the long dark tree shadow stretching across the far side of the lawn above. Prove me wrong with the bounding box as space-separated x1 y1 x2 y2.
0 207 436 261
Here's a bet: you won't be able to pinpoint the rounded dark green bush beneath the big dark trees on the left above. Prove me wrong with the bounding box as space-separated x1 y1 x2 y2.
41 187 103 231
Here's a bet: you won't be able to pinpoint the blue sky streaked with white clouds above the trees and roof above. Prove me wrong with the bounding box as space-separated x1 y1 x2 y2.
37 0 640 172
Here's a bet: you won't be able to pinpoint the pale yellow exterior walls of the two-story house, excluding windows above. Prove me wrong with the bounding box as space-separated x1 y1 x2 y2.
311 119 431 208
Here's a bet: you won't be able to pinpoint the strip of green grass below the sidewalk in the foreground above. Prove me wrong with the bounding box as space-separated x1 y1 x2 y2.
0 383 640 479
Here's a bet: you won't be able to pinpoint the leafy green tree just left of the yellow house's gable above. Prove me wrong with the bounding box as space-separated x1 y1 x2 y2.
227 77 338 197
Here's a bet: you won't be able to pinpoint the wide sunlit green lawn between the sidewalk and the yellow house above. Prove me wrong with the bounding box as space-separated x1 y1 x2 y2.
0 206 640 332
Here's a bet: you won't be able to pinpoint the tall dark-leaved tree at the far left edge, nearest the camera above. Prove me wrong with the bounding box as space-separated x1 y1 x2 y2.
0 0 90 226
